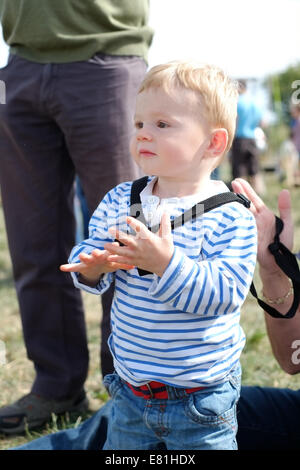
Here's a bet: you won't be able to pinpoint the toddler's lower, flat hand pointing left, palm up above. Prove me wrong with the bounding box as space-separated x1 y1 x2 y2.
60 246 134 284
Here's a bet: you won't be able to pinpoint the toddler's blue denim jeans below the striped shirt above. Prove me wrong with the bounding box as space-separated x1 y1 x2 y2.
103 367 240 450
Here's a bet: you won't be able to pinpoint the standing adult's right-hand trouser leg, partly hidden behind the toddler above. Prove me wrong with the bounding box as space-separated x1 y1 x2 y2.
53 54 146 376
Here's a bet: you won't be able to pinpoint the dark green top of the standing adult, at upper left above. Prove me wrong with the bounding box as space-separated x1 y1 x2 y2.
0 0 153 63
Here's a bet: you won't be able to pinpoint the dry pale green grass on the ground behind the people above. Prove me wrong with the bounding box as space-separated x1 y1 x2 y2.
0 162 300 449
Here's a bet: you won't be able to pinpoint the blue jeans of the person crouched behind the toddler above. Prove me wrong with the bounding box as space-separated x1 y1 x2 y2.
11 387 300 451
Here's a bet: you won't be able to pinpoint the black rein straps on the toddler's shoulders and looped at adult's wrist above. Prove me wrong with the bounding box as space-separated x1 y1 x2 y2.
130 176 300 318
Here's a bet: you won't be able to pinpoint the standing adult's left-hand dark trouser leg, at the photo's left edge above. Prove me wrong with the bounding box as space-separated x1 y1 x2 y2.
0 57 88 399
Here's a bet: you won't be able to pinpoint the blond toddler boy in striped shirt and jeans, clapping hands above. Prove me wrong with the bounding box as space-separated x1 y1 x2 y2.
61 62 256 450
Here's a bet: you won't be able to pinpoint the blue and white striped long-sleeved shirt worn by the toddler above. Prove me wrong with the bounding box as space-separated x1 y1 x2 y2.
69 178 257 387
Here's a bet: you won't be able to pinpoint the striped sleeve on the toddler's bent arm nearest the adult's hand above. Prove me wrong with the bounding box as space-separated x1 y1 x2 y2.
149 208 257 316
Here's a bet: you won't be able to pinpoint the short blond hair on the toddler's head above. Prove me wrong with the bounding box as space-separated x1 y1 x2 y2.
139 61 239 153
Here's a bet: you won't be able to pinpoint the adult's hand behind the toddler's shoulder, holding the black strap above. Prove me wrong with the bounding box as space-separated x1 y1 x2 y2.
232 178 294 275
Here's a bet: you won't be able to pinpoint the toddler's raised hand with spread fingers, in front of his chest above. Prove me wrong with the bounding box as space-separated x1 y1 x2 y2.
104 214 174 277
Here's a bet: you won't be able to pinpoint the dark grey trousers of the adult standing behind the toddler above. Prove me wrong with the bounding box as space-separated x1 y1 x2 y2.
0 54 146 398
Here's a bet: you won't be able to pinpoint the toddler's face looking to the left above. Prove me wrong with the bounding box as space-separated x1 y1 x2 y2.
130 88 210 181
